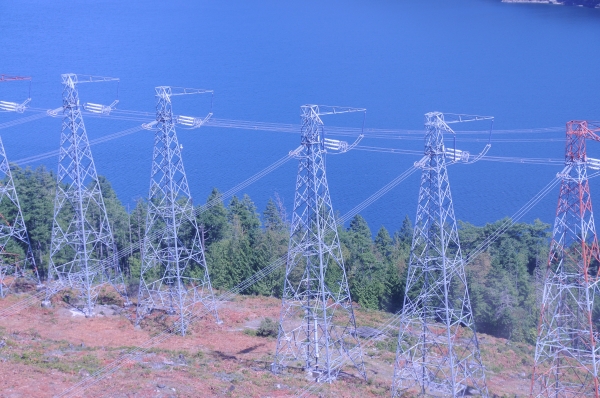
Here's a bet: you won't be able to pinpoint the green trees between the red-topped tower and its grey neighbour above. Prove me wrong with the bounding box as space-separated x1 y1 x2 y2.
459 220 549 343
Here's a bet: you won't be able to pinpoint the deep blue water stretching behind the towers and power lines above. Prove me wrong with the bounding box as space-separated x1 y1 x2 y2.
0 0 600 232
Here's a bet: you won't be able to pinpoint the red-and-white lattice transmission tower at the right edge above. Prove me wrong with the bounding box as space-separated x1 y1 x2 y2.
531 121 600 397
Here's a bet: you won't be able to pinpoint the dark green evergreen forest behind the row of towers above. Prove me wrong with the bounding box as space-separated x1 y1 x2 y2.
7 166 550 343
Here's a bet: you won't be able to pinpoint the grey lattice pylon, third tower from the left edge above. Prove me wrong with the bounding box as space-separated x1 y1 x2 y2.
137 87 221 335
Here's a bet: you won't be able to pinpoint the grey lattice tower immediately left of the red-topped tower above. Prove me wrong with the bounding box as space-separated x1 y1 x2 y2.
392 112 487 397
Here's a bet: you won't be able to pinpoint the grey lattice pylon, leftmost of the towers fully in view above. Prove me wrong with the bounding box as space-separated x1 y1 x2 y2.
43 74 128 316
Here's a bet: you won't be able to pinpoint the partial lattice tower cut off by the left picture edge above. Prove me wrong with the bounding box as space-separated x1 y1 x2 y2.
0 139 40 297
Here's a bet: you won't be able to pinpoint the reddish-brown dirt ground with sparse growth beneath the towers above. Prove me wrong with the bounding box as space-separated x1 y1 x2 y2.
0 294 533 398
